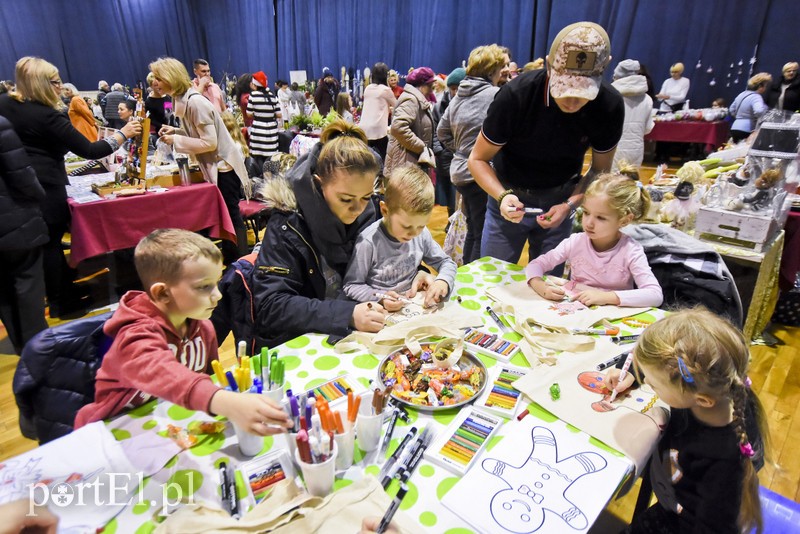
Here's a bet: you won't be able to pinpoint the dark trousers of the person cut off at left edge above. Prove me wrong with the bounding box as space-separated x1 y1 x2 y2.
0 247 47 354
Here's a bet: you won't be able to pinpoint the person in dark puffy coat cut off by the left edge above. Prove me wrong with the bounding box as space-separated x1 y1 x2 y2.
0 116 47 354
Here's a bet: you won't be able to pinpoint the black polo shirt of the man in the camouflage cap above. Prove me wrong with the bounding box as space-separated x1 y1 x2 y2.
482 69 625 189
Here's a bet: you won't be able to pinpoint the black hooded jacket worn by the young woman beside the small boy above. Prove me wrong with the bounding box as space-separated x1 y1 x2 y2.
250 144 376 350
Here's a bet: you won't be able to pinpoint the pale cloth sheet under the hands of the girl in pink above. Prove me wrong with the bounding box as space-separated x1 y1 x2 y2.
486 282 650 330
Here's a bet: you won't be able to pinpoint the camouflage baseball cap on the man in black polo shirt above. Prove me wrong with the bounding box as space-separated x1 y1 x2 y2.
547 22 611 100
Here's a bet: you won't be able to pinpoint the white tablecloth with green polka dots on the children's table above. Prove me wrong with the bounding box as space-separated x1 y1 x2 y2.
103 258 648 534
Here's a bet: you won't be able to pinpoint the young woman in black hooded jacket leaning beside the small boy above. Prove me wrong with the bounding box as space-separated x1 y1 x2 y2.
251 119 385 349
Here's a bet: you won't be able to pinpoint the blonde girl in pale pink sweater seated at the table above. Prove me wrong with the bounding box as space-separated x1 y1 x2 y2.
525 174 664 307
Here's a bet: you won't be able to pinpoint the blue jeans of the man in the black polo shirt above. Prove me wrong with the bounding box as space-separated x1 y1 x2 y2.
481 183 575 268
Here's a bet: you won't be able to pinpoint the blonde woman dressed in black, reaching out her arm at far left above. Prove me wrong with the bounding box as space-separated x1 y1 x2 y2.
0 57 142 317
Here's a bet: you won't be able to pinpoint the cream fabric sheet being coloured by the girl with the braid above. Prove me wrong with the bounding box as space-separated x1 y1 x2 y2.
514 337 669 473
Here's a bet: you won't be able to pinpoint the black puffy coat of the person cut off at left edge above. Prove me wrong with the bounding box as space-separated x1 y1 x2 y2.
0 116 48 250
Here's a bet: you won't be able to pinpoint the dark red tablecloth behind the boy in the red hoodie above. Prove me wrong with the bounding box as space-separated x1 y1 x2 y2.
69 183 236 267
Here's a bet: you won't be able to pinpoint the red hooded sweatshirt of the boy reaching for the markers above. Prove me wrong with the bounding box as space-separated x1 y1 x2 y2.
75 291 220 429
